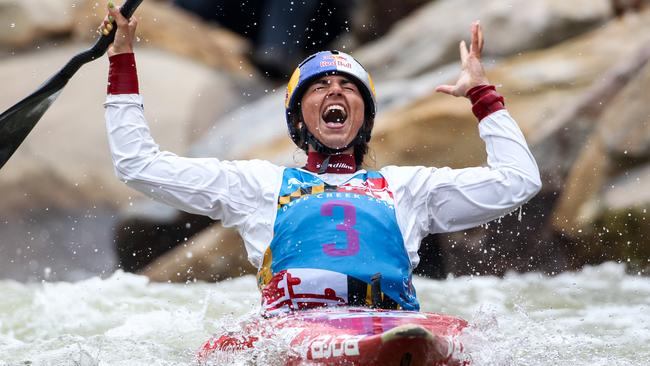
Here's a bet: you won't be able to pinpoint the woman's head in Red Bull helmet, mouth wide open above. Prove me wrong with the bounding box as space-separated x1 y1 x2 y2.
285 51 376 169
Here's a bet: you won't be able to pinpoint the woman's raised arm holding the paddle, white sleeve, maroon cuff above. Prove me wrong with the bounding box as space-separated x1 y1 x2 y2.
100 5 281 226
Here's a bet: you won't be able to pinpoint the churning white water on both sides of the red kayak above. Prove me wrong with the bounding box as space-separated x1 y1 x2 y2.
0 263 650 366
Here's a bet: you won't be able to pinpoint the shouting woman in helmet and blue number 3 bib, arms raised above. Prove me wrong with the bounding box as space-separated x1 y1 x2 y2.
100 6 541 314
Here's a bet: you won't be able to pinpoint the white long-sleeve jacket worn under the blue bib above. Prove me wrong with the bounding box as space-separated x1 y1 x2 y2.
105 94 541 268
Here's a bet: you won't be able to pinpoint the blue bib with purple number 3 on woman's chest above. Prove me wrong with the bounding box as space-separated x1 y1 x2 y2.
269 169 419 310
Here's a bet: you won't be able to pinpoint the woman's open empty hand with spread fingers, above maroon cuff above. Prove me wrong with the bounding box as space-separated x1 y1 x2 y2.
436 21 489 97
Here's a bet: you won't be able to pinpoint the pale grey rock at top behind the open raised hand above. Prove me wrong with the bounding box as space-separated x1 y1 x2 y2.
355 0 611 79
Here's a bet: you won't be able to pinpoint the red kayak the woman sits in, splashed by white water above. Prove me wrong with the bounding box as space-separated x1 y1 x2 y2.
197 308 469 366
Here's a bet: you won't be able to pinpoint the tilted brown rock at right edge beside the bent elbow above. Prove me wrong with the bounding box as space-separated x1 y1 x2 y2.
548 40 650 235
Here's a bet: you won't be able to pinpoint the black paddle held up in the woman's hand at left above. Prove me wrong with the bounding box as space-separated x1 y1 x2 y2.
0 0 142 168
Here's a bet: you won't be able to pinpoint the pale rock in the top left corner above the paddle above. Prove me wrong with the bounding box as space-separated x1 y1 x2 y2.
0 0 78 48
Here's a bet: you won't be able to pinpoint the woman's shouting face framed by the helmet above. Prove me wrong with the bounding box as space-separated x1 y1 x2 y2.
301 75 365 153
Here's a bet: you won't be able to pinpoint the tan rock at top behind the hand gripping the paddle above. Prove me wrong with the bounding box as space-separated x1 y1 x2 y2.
75 0 254 77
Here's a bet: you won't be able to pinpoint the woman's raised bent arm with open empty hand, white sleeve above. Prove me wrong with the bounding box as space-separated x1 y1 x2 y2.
387 22 541 237
